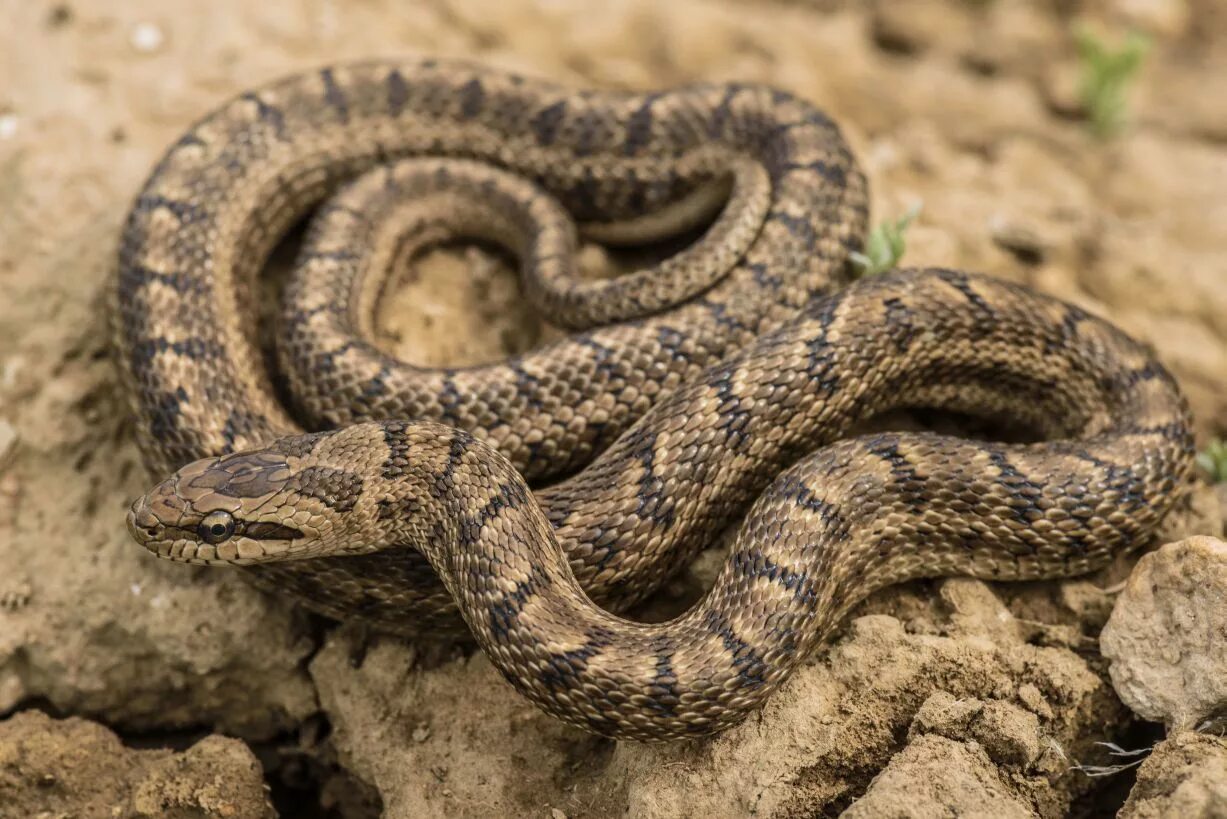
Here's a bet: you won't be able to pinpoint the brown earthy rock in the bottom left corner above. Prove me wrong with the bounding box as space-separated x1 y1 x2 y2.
0 711 276 819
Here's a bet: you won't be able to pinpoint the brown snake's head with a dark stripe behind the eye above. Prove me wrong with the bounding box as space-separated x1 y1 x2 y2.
128 436 367 565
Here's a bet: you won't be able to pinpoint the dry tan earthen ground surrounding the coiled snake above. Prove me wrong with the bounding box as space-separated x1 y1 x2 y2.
0 0 1227 819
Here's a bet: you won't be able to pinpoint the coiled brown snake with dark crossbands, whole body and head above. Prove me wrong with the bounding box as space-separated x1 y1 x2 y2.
112 59 1193 742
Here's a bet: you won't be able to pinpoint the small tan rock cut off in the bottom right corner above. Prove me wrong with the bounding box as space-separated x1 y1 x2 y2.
1119 732 1227 819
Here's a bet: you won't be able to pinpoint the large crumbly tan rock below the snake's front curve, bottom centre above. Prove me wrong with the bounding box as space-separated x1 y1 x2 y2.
310 599 1125 819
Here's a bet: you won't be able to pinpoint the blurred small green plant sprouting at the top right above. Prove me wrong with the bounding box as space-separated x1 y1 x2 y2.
1074 26 1150 139
